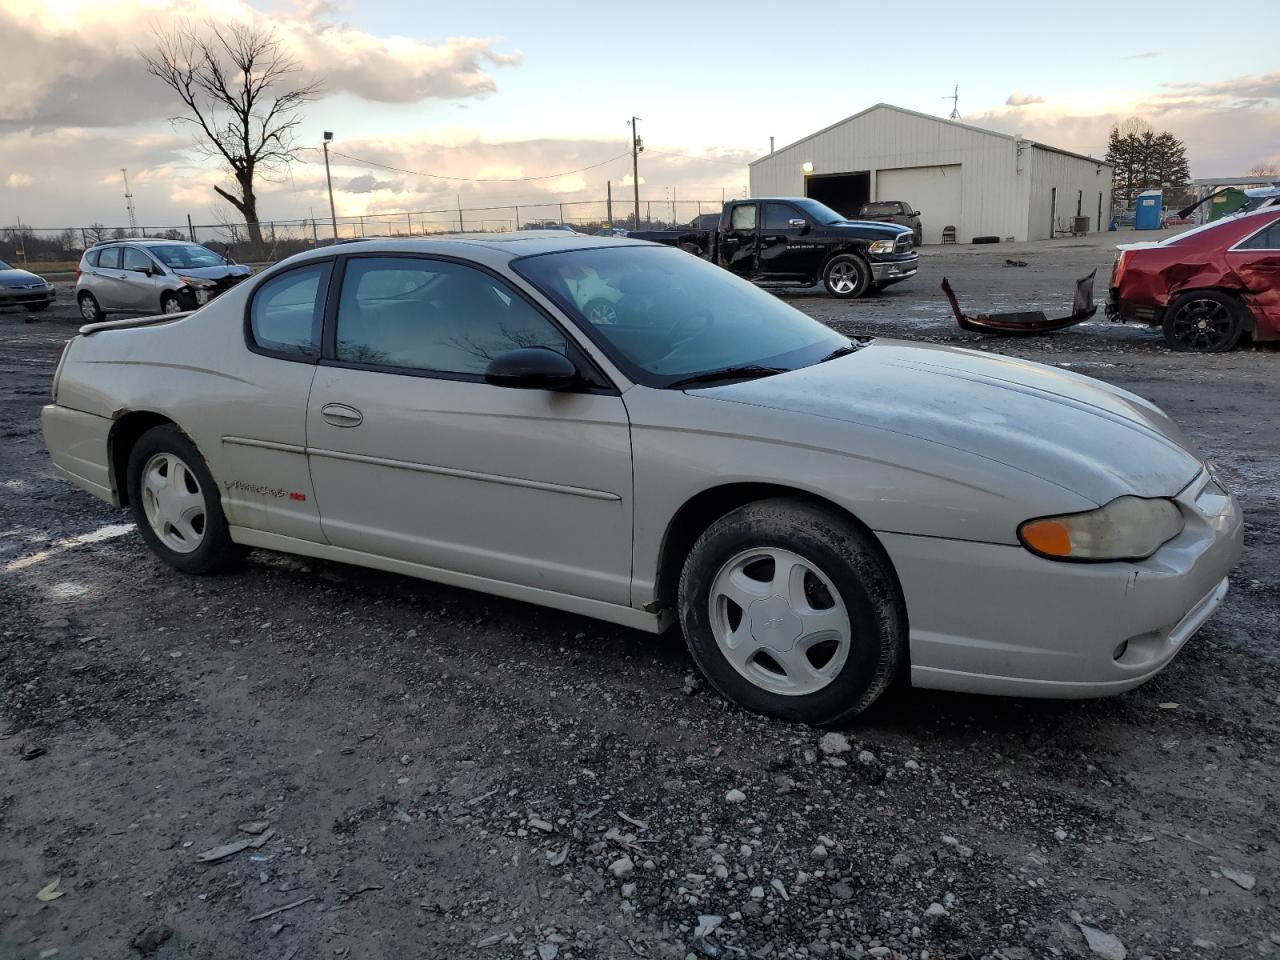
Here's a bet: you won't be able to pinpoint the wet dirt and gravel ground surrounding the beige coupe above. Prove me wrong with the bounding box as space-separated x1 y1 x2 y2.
0 234 1280 960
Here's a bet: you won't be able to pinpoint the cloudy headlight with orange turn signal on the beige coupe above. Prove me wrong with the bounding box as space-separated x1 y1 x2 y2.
1018 497 1183 562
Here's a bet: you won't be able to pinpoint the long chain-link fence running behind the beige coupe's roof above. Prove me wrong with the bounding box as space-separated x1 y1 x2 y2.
0 198 721 270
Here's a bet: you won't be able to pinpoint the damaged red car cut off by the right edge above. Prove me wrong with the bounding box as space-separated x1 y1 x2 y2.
1107 207 1280 353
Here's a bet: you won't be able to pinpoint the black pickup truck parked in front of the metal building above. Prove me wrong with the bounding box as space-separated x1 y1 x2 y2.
630 197 920 300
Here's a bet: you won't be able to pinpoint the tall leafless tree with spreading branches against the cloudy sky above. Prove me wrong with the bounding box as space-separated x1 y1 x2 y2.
143 22 320 247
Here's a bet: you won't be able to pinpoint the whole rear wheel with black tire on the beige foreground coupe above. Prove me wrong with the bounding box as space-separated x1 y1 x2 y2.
127 424 243 575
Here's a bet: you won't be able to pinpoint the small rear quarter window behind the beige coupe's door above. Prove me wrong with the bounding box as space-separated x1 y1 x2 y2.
248 260 333 360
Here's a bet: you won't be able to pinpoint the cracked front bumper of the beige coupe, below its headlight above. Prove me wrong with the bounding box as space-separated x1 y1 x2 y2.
881 472 1243 698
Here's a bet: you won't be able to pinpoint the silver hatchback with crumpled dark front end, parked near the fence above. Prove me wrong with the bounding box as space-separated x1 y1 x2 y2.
76 239 253 323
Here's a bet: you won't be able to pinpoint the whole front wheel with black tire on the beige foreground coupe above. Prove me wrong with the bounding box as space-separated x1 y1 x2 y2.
678 498 906 726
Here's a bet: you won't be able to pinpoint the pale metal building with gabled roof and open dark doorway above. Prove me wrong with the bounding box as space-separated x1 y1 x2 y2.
750 104 1111 243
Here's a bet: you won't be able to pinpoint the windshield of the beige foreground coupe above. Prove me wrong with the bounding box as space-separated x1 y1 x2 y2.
512 246 850 387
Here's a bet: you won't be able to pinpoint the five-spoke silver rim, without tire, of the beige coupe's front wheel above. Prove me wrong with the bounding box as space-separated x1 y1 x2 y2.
708 547 852 696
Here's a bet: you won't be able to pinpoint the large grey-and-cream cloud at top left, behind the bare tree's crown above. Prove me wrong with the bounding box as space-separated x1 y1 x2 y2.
0 0 521 129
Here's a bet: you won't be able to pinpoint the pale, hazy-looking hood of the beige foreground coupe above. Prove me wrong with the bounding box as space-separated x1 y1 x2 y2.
698 340 1201 506
